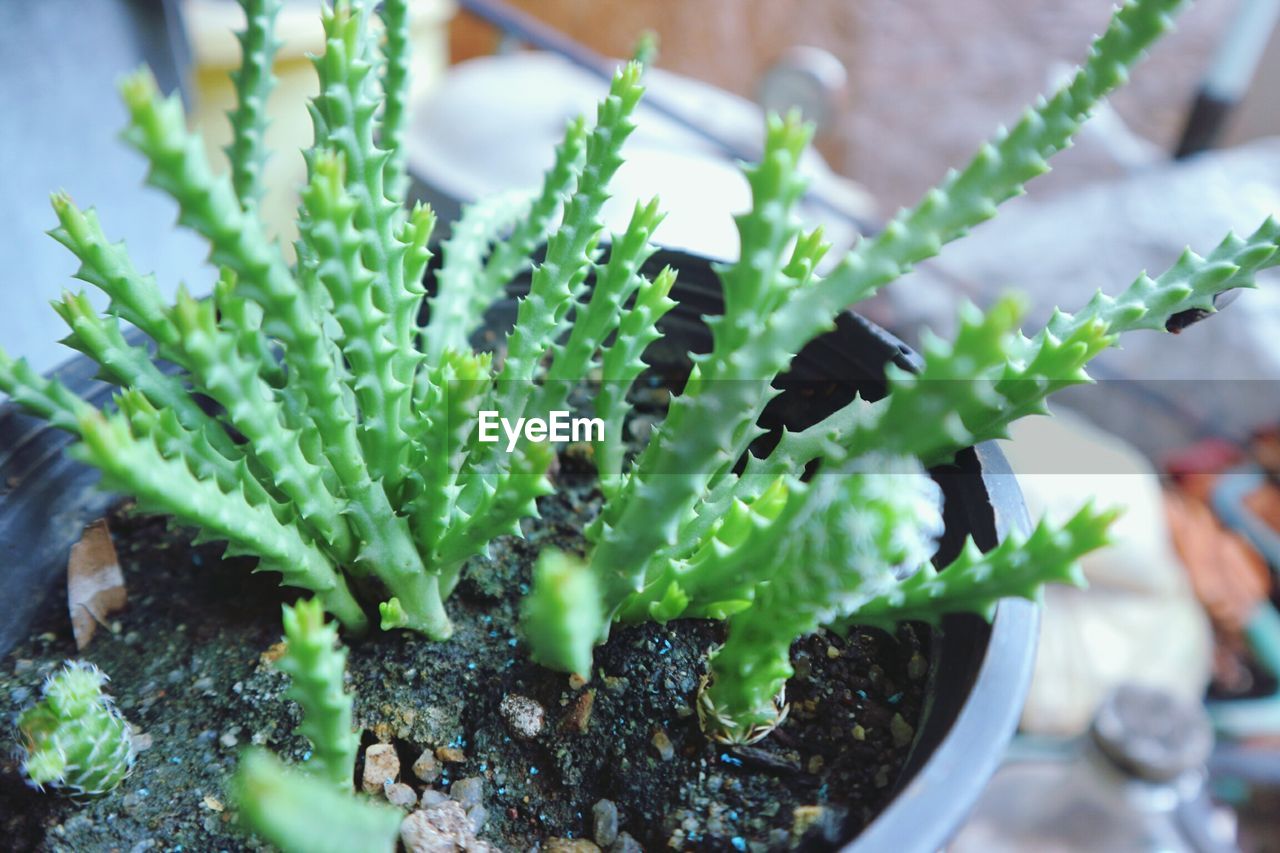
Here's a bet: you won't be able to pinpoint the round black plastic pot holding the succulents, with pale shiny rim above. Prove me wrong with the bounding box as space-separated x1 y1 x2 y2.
0 245 1037 852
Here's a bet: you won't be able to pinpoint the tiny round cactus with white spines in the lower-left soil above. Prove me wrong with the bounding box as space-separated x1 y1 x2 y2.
18 661 134 795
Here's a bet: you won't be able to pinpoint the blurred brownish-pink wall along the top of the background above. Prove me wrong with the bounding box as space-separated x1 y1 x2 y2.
452 0 1234 206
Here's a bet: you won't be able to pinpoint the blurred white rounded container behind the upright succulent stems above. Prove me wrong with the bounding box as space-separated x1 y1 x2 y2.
407 51 874 260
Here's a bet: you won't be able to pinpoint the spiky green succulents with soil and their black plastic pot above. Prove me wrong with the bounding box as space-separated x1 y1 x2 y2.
0 0 1280 850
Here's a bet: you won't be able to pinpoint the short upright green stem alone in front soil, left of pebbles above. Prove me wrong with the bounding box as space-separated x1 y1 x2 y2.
275 598 360 792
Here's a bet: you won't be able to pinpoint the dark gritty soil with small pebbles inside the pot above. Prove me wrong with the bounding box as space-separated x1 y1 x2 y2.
0 438 928 850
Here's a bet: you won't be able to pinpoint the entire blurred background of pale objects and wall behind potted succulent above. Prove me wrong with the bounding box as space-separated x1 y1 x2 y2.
0 0 1280 850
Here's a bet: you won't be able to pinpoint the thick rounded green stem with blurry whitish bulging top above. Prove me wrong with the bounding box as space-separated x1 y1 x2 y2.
701 456 943 740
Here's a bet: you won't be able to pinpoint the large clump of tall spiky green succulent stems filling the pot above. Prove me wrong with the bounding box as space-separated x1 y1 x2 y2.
0 0 1280 740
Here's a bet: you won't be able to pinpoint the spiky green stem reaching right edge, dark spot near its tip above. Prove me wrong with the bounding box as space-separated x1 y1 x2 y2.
748 218 1280 476
